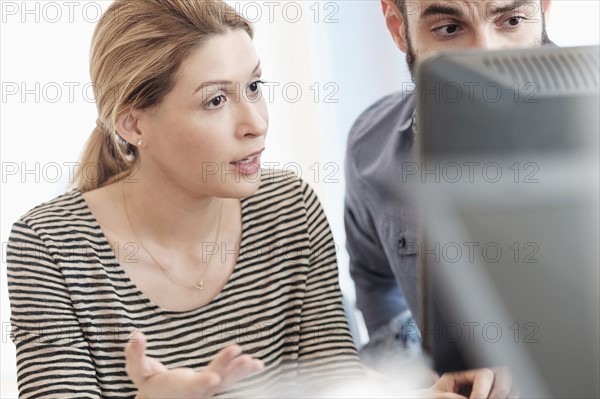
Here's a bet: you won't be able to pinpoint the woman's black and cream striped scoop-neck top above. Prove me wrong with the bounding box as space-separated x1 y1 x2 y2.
7 171 361 398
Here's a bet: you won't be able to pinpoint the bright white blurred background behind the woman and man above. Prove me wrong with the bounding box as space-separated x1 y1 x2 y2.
0 0 600 398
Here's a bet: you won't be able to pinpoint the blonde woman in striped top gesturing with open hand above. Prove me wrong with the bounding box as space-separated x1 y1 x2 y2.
7 0 361 398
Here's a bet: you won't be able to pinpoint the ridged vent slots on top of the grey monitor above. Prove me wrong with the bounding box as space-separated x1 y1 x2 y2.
483 49 600 91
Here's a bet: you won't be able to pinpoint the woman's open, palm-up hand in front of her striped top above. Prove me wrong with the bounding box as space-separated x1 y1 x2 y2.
125 332 264 399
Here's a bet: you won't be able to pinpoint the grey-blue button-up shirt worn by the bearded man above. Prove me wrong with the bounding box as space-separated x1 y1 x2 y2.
345 93 418 342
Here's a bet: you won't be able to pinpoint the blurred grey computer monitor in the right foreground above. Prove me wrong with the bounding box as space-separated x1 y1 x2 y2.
414 46 600 397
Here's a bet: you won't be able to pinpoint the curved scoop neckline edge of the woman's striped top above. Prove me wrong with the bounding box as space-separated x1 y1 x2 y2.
73 188 248 315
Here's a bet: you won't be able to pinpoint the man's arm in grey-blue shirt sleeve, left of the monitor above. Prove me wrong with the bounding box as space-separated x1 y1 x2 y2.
344 92 414 335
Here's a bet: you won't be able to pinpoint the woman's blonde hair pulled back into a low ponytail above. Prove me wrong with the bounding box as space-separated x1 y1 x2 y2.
73 0 253 192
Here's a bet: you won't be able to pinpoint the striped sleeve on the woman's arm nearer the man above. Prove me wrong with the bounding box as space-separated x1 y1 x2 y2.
299 182 362 379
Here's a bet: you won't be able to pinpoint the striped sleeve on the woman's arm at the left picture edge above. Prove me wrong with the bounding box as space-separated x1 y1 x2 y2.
7 220 101 398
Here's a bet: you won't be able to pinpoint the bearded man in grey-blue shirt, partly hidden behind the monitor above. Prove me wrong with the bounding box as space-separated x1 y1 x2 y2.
345 0 550 390
